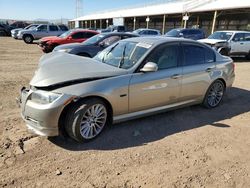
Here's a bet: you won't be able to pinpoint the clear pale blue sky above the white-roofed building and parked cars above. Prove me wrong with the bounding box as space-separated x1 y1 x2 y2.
0 0 163 20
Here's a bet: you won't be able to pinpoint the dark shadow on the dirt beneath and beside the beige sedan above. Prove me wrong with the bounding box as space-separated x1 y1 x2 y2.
49 88 250 151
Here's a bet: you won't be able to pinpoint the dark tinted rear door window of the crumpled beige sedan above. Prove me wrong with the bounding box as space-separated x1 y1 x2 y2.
182 44 206 66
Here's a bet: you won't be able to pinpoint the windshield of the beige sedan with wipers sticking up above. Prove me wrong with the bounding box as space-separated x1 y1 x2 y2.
94 41 151 69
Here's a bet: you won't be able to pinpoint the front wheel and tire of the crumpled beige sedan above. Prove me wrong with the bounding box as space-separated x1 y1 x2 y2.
65 99 108 142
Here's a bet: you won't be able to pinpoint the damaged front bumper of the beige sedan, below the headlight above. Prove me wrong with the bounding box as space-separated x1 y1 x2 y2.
17 88 70 136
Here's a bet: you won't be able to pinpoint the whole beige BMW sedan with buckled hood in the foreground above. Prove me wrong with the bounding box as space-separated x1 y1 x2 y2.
20 37 235 142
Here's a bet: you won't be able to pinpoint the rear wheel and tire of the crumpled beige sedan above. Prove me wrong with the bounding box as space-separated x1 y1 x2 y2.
203 80 225 108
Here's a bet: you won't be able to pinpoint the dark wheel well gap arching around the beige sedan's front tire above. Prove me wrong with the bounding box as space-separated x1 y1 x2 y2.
58 96 113 135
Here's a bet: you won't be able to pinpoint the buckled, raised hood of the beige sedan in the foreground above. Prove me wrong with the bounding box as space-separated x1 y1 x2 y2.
30 52 128 88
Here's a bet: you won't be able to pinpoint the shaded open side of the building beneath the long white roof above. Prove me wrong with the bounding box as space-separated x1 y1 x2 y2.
69 8 250 35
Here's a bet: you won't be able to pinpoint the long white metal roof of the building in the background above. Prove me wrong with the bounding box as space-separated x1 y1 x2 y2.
70 0 250 21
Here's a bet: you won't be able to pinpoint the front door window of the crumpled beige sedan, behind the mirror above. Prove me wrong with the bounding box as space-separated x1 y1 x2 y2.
146 44 179 70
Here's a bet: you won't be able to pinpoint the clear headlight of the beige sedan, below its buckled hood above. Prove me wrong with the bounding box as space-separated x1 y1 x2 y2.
30 90 62 104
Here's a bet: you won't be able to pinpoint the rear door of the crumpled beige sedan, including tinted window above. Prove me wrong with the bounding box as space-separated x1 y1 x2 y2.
180 42 215 102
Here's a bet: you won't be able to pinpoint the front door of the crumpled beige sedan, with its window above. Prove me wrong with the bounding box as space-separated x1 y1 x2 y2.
129 43 182 112
